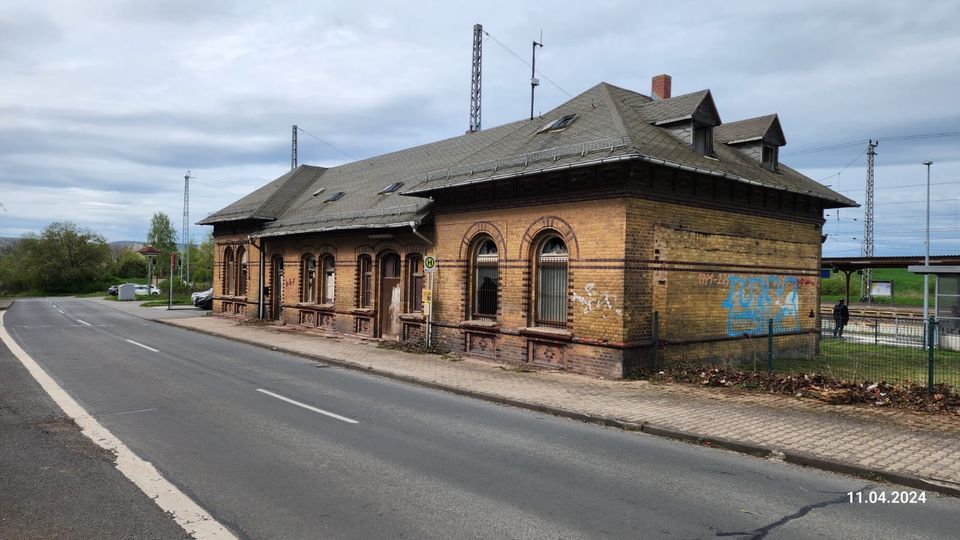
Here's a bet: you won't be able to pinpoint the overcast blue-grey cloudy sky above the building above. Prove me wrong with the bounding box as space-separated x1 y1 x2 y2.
0 0 960 256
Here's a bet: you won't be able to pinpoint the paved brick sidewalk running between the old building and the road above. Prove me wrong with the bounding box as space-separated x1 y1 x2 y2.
146 317 960 496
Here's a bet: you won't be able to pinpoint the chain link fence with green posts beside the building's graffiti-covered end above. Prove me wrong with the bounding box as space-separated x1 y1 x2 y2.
654 314 960 388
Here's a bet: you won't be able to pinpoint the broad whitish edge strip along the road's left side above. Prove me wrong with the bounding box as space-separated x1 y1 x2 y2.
0 311 236 540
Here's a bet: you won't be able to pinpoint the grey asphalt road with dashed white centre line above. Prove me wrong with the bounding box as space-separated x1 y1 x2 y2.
5 299 960 539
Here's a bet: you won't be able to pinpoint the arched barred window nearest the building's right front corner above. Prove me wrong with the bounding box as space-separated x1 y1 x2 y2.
534 236 568 326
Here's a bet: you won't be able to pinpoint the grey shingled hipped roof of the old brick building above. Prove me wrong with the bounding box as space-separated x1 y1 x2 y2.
200 83 856 236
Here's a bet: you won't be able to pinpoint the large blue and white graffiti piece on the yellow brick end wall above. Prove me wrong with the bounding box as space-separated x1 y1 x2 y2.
721 274 800 336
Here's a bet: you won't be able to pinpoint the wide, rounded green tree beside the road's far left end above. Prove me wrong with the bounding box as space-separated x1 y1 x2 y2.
13 222 110 293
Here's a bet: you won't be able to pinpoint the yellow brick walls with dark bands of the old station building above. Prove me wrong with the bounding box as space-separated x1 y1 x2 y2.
214 163 822 377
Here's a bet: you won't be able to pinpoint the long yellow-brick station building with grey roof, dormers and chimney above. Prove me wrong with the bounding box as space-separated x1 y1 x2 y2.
201 75 855 377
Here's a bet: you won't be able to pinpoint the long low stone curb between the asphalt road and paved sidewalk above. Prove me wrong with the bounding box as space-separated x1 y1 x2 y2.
155 319 960 497
